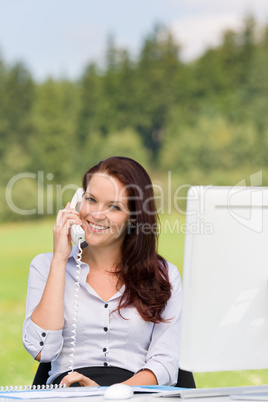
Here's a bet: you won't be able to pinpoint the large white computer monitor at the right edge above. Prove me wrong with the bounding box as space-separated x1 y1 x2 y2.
180 186 268 372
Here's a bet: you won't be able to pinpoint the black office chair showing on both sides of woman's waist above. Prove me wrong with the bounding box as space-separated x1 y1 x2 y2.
33 363 196 388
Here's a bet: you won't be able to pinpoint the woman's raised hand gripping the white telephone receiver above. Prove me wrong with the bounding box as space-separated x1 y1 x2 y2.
53 202 82 261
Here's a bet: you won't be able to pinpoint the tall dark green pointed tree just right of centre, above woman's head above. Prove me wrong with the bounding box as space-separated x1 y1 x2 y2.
136 26 181 156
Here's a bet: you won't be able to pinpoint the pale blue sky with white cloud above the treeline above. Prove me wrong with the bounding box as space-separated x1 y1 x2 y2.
0 0 268 81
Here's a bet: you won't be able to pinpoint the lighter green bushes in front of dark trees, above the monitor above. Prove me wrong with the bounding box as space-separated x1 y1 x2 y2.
160 115 262 173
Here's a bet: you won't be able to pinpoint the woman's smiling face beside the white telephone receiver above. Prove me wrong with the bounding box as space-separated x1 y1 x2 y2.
80 173 130 247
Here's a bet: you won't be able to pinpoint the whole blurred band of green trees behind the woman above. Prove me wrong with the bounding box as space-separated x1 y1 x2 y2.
0 16 268 221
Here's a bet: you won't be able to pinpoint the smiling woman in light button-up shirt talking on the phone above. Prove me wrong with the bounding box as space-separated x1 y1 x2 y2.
23 157 181 386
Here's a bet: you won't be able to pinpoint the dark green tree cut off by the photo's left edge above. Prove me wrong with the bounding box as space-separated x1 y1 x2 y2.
0 61 35 184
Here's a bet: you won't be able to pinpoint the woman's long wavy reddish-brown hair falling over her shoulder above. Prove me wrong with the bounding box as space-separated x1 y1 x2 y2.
83 156 171 323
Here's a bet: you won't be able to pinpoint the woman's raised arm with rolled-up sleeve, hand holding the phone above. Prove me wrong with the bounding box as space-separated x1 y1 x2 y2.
23 204 81 361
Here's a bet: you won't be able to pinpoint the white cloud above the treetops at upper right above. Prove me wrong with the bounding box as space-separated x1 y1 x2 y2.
170 13 242 61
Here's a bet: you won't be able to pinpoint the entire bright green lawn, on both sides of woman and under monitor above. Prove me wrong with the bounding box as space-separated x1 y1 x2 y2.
0 216 268 387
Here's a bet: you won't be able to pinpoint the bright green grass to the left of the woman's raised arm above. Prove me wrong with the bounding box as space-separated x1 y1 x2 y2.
0 220 53 385
